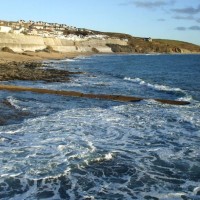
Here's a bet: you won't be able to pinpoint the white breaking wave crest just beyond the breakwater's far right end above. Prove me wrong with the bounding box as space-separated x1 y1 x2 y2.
124 77 185 94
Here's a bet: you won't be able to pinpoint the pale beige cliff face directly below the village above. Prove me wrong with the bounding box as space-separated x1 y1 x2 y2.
0 33 127 53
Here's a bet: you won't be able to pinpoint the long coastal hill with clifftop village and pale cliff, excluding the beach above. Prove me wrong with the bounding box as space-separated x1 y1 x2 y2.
0 20 200 53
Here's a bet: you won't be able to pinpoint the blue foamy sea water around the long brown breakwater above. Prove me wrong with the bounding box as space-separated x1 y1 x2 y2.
0 55 200 200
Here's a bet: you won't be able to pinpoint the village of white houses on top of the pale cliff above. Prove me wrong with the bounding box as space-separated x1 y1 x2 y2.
0 20 107 40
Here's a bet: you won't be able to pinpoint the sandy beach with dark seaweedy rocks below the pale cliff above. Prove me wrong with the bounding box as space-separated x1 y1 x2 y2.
0 52 92 82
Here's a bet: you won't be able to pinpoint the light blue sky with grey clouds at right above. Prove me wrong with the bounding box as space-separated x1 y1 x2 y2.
0 0 200 45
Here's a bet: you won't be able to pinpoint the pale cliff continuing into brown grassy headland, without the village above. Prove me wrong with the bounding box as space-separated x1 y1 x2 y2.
0 31 200 53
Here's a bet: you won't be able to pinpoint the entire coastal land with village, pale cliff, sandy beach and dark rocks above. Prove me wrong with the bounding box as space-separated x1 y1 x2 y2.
0 20 200 86
